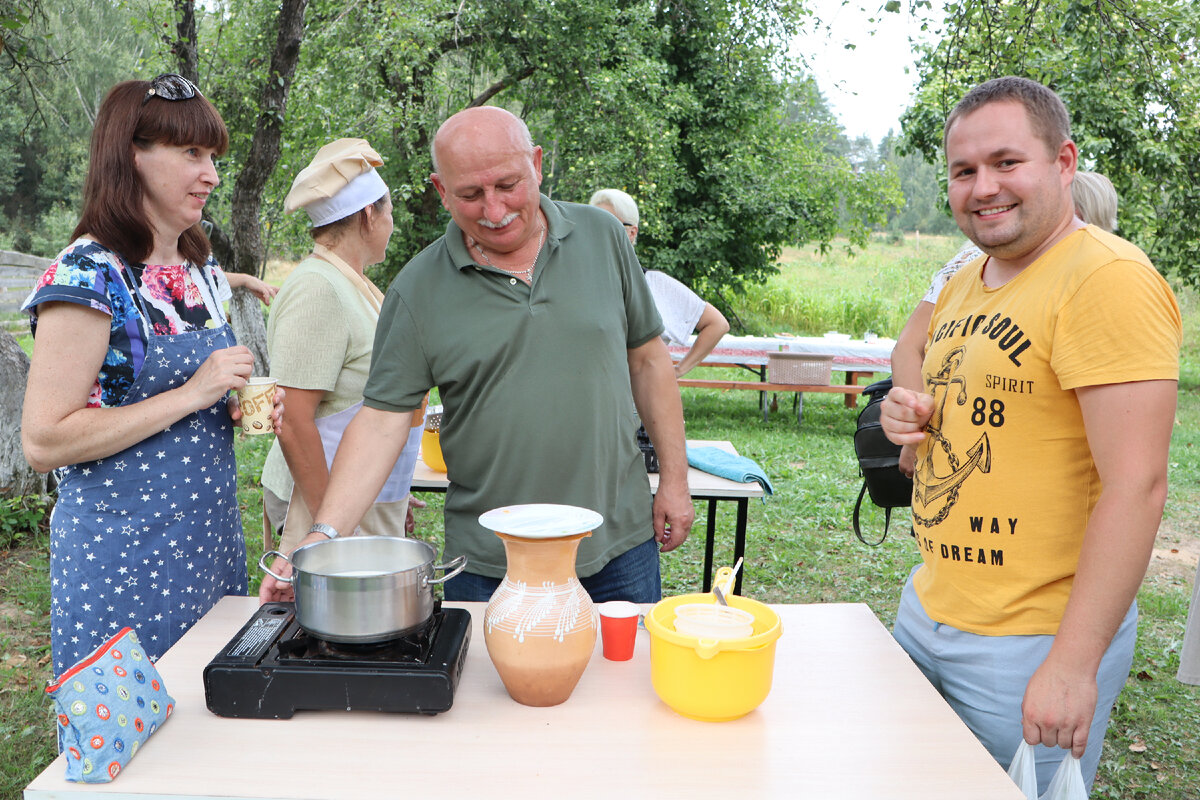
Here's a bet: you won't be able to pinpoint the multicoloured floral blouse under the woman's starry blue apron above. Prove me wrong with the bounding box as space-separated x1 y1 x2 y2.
22 239 233 408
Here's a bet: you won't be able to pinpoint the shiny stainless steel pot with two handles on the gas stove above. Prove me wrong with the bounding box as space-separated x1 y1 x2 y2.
258 536 467 643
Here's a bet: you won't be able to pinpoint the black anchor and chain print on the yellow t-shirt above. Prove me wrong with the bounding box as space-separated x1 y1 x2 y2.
912 348 991 528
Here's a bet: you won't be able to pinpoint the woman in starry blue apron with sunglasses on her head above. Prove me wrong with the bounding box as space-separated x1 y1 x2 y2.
22 76 282 674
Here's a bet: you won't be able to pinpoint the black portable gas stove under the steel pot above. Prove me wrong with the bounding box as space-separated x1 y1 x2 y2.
204 602 470 720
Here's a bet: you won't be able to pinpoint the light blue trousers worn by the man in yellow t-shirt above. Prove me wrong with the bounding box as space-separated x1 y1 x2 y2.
893 566 1138 793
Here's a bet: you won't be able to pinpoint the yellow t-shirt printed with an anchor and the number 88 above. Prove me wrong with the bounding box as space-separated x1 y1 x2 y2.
912 225 1182 636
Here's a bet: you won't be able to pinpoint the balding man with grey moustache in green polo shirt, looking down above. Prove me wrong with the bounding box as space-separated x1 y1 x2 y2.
262 107 692 602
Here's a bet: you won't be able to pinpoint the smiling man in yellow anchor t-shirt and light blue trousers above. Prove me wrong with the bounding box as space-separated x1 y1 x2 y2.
881 78 1182 792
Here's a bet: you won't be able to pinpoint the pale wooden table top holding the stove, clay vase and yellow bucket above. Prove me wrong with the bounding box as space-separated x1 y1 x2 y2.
25 597 1021 800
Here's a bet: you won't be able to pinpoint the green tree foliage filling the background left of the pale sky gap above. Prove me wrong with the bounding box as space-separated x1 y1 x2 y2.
0 0 900 301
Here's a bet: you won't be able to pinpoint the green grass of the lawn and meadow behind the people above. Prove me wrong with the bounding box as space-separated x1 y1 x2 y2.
0 237 1200 800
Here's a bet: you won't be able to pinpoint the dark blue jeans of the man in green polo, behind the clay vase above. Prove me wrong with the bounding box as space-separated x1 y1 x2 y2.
444 536 662 603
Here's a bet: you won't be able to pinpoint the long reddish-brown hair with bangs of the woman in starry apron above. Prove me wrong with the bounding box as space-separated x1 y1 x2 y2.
71 80 229 266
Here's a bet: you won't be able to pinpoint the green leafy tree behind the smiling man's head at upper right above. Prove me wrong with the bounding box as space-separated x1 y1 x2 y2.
902 0 1200 284
